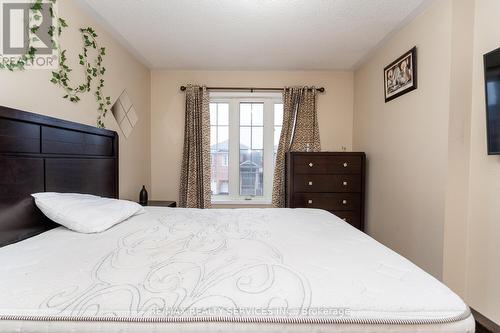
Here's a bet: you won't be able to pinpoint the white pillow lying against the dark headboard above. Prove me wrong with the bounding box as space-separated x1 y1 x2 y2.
31 192 144 234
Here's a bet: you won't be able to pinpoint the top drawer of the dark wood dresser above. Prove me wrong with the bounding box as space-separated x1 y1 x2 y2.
293 154 363 174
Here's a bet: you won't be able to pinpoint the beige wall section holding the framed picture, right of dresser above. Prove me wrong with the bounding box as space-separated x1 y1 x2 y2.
353 1 451 277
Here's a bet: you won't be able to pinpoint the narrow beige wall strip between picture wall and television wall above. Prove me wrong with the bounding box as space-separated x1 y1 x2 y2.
443 0 474 297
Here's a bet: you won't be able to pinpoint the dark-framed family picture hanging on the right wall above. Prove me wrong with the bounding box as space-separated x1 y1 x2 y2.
384 47 417 103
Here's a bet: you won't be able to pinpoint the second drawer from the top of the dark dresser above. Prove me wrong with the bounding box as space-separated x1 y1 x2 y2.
293 175 361 192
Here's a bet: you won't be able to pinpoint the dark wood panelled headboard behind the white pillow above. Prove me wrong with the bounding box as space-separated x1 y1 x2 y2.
0 106 118 247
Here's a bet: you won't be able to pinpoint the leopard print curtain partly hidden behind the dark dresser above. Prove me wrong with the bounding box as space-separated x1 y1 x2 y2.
272 87 321 208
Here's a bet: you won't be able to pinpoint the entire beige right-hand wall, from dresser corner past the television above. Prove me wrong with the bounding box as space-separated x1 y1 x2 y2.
353 0 500 323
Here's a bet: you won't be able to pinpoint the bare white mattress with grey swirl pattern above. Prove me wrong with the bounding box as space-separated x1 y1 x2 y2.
0 207 474 333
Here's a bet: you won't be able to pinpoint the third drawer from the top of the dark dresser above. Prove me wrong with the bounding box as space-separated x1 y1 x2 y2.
293 193 361 210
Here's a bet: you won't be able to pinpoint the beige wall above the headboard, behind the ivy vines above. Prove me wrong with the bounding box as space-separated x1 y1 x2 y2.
0 0 150 199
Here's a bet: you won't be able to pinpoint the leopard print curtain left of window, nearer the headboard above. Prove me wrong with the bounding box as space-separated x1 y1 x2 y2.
179 85 211 208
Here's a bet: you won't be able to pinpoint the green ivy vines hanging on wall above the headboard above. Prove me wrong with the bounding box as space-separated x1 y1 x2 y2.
0 0 111 128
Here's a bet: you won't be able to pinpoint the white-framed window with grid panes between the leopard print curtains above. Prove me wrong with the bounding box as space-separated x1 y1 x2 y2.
210 93 283 203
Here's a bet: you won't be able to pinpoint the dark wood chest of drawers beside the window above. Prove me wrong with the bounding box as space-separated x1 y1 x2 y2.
286 152 366 230
